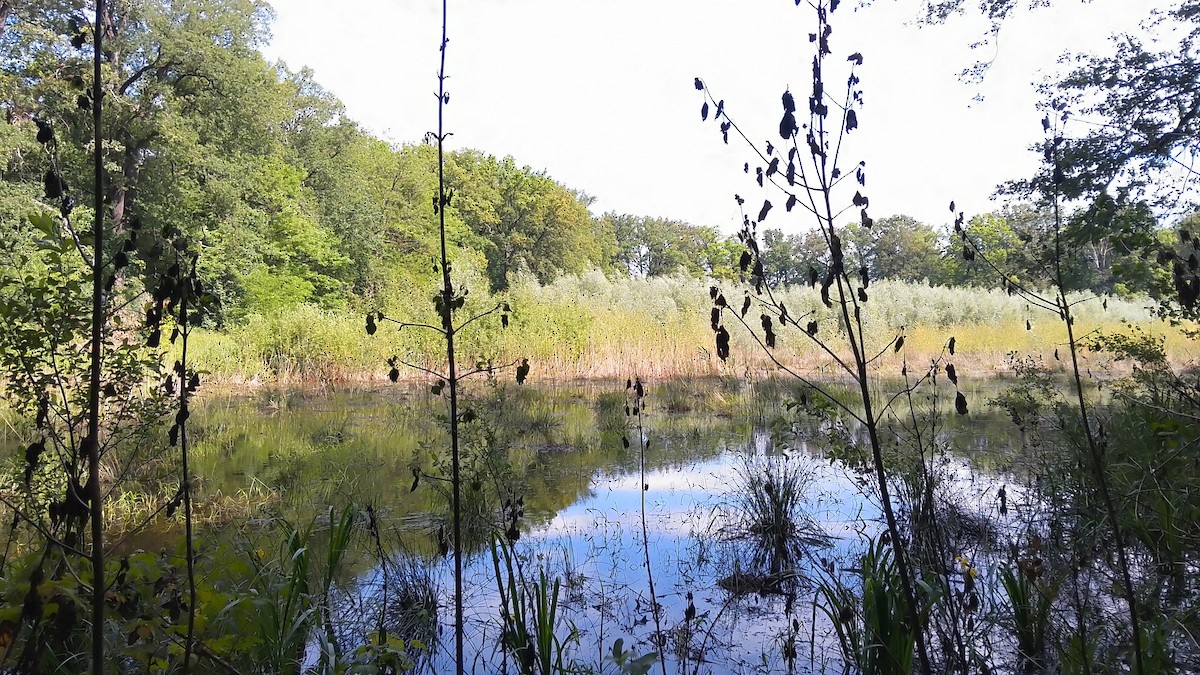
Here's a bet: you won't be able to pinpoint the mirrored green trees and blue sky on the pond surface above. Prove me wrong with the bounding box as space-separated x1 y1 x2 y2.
182 374 1012 673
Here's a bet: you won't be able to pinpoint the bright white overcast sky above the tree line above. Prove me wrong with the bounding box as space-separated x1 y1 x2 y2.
263 0 1156 233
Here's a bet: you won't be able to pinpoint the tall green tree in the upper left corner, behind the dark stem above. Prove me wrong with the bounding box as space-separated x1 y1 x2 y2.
0 0 292 314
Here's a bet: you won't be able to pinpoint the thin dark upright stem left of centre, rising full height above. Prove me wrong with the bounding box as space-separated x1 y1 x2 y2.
438 0 464 675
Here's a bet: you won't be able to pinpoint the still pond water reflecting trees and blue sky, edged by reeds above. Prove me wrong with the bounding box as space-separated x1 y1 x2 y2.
182 380 1021 674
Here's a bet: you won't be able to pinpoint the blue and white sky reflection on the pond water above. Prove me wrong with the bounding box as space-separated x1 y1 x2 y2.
345 436 1024 674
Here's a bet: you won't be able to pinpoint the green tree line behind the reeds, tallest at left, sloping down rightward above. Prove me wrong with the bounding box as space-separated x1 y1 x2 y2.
0 0 1180 322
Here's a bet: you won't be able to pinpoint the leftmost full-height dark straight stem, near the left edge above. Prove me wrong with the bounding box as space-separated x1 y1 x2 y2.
84 0 104 675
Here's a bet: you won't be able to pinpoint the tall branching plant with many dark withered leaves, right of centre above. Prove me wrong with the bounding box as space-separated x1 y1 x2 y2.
695 0 936 674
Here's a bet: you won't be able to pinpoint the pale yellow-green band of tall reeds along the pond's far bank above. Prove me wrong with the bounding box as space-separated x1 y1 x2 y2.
188 273 1180 384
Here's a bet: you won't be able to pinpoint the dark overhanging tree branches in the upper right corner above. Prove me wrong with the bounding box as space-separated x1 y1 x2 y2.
922 0 1200 207
